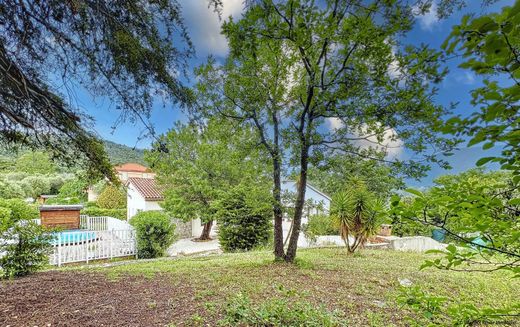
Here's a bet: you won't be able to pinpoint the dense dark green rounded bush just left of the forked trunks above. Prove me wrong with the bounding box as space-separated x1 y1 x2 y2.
217 183 272 252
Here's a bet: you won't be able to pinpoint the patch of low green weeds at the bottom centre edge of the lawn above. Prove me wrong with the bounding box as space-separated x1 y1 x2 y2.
219 293 346 327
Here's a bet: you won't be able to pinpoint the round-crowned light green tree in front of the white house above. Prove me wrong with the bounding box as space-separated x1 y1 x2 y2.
145 120 267 240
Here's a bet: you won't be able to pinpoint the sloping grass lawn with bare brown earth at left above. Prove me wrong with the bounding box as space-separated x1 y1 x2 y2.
0 248 520 326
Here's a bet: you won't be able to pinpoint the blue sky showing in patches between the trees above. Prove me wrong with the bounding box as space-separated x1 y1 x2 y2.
64 0 513 187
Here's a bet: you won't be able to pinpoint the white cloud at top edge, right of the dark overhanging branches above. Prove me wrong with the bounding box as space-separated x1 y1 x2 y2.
179 0 244 57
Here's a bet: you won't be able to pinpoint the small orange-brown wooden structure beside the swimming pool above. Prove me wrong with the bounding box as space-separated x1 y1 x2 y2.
40 205 83 229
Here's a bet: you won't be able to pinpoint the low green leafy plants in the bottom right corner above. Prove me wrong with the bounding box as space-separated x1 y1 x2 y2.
397 286 520 327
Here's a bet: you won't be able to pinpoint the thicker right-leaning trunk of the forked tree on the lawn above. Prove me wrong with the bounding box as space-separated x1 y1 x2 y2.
285 144 309 262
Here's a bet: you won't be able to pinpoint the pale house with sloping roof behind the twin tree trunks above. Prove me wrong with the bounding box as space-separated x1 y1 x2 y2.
282 180 331 223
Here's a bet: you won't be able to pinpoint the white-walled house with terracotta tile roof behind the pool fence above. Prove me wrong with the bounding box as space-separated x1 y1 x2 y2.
126 177 210 238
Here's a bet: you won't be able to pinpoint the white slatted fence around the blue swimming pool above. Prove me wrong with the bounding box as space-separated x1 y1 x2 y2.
49 229 137 266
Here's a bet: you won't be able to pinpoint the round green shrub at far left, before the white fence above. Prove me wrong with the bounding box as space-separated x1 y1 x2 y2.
0 219 53 278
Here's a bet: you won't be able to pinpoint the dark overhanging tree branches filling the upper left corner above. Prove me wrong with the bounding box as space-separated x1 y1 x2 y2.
0 0 202 176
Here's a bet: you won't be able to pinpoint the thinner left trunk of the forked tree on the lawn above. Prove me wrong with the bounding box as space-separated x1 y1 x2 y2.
273 155 285 260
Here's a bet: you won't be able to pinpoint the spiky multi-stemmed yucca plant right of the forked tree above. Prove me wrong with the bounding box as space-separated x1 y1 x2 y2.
331 181 384 253
